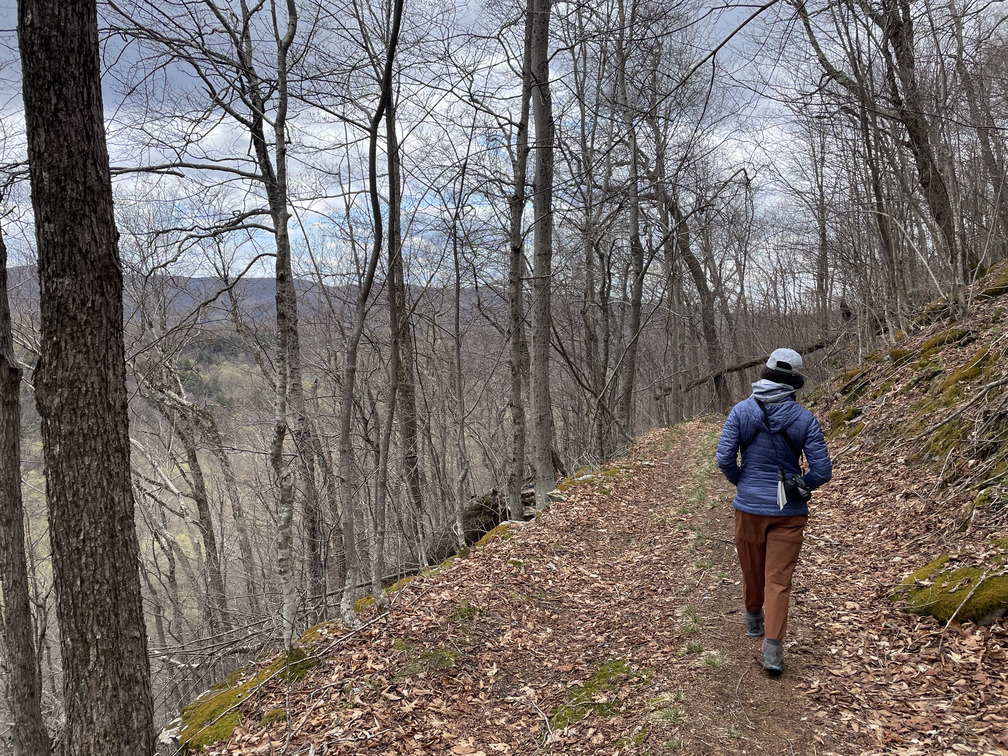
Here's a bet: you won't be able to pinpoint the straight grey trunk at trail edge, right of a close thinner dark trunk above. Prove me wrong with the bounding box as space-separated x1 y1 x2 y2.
530 0 556 508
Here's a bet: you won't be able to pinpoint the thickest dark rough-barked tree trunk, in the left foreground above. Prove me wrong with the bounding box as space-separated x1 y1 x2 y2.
18 0 154 756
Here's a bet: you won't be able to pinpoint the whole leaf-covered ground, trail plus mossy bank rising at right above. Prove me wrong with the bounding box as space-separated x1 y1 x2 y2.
173 274 1008 756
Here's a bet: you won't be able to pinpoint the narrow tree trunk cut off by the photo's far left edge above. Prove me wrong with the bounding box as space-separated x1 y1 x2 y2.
0 229 49 756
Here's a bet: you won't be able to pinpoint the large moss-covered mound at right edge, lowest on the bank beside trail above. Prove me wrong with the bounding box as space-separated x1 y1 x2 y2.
896 555 1008 624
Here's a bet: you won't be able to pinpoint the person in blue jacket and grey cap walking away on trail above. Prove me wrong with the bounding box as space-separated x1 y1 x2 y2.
718 349 833 673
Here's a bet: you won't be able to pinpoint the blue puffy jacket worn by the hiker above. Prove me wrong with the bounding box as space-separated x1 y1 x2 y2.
718 396 833 516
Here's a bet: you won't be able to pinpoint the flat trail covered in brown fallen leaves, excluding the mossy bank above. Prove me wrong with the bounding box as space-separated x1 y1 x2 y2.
196 419 1008 756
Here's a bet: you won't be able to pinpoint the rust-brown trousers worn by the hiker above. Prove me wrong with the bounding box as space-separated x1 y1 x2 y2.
735 509 808 640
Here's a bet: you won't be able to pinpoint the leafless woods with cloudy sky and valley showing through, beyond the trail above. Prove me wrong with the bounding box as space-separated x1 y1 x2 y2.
0 0 1008 741
